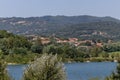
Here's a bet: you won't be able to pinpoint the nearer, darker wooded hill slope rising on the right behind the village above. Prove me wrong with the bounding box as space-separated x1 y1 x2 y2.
56 21 120 40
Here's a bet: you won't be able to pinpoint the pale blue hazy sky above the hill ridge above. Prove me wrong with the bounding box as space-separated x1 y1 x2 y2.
0 0 120 19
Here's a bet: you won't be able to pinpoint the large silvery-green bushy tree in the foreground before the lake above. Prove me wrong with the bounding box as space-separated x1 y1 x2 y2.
23 54 66 80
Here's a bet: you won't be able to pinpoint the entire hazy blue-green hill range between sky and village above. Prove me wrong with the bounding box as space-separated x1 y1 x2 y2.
0 15 120 39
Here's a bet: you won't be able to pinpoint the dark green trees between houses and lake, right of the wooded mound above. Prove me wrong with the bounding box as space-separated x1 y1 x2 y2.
31 38 120 61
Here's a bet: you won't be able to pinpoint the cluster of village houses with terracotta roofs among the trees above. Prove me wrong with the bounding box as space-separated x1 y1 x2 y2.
27 35 103 47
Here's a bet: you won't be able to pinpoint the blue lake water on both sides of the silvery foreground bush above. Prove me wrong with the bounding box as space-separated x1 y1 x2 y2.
7 62 117 80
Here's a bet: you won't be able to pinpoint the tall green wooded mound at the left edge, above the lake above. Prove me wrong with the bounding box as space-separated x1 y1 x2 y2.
0 30 35 63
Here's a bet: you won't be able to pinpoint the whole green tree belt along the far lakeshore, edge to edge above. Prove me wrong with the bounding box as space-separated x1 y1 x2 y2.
0 30 120 63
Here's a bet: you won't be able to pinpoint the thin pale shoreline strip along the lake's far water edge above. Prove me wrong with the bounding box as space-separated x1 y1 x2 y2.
6 57 120 65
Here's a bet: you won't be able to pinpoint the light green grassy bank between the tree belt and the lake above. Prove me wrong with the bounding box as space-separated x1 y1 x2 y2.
4 54 120 65
